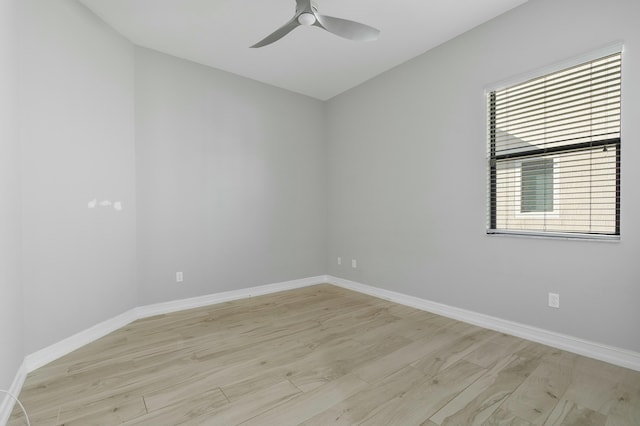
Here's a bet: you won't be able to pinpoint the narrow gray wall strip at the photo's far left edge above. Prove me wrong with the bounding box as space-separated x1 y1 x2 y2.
0 0 23 392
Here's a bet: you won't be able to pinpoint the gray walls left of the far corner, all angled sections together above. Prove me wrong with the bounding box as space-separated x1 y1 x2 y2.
0 0 326 360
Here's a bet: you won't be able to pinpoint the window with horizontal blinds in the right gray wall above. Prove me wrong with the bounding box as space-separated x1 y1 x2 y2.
487 52 622 237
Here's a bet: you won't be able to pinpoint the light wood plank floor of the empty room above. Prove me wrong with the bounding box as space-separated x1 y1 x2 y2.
9 285 640 426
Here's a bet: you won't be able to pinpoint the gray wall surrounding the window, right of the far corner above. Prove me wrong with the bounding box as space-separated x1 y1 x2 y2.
327 0 640 351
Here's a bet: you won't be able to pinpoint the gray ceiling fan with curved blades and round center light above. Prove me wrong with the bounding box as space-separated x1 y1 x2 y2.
251 0 380 48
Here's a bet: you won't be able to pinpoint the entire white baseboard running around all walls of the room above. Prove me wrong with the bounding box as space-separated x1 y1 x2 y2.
6 275 640 424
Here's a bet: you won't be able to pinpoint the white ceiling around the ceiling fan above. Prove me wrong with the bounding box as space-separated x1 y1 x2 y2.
79 0 527 100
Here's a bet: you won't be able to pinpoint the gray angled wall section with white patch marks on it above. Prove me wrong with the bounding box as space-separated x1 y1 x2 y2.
19 0 136 353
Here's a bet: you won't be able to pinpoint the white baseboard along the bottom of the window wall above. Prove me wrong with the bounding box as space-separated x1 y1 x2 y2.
327 276 640 371
